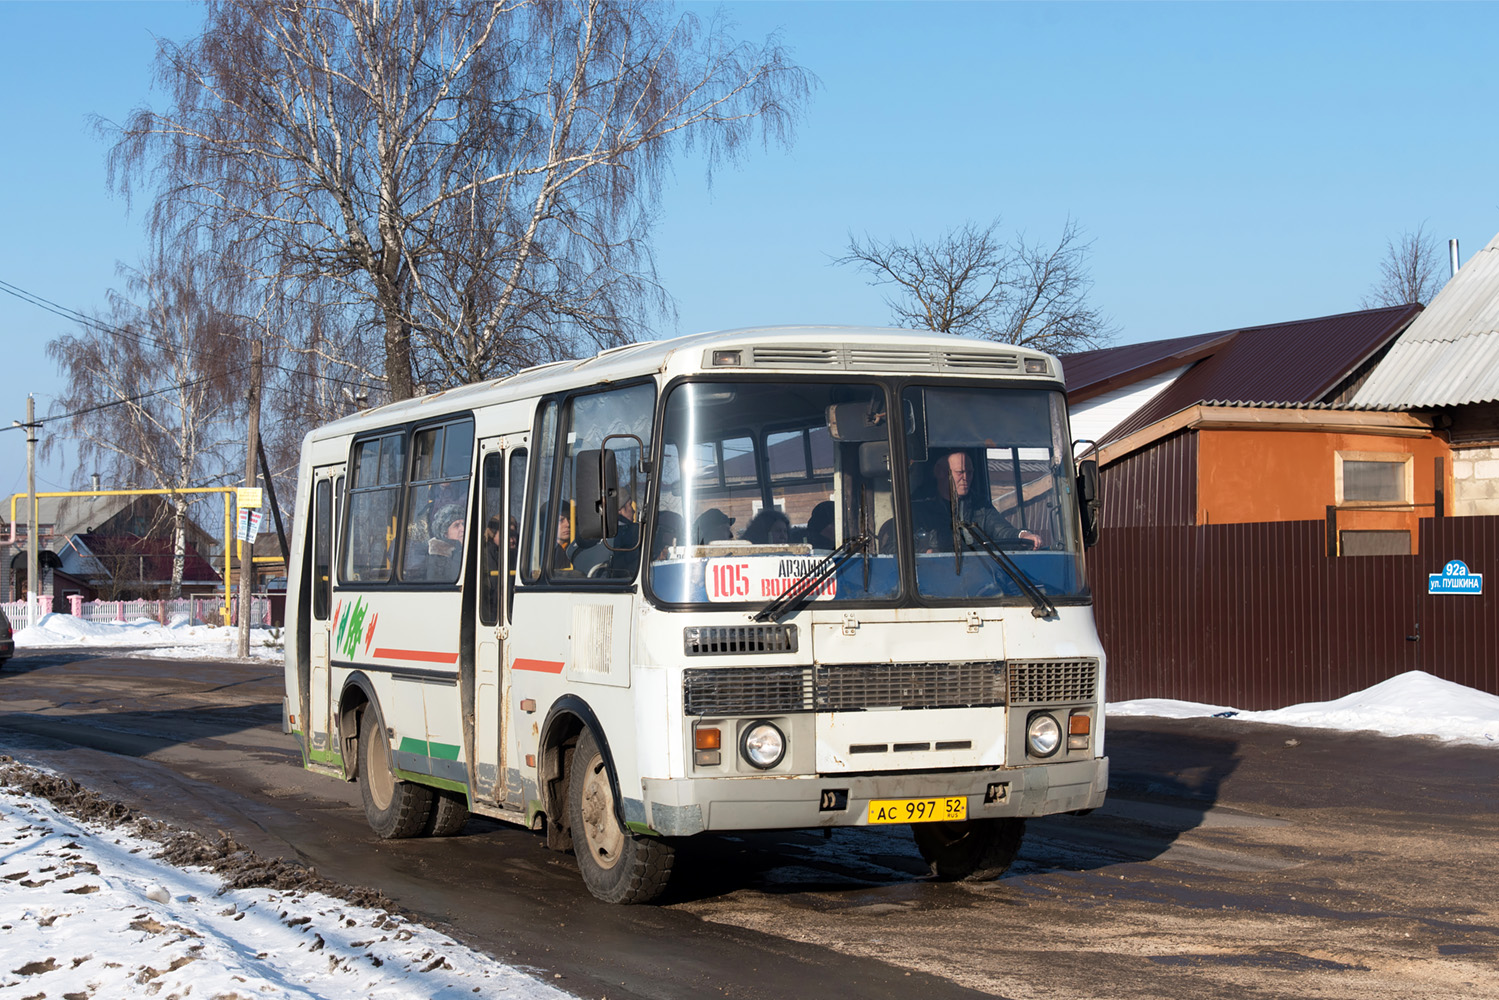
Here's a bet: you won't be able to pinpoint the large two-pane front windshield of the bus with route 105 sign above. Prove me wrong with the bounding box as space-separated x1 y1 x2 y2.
649 379 1085 609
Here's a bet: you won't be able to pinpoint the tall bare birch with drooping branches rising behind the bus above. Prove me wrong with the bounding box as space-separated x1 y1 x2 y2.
109 0 809 399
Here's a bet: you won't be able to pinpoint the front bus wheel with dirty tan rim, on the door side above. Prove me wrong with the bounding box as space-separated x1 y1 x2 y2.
567 729 676 903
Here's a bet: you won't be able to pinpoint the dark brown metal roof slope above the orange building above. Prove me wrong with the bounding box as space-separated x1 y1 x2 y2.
1067 304 1421 441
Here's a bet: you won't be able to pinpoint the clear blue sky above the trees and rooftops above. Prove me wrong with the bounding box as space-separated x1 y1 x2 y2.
0 1 1499 496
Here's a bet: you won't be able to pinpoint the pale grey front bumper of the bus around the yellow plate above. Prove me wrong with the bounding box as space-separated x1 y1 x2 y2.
638 757 1109 837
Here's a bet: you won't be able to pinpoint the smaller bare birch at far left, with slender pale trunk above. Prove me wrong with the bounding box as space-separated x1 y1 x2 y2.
43 242 247 598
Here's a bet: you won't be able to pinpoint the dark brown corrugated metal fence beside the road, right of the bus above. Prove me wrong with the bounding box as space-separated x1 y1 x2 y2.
1088 517 1499 709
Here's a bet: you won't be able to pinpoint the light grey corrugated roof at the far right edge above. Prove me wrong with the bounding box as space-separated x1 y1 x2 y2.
1352 235 1499 406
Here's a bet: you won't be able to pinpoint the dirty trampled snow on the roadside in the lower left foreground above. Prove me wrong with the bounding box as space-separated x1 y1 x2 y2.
0 765 570 1000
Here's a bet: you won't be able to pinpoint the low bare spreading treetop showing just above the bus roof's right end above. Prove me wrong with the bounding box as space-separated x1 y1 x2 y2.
835 219 1114 354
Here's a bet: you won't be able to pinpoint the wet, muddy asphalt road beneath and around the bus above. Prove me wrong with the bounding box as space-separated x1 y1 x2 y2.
0 649 1499 1000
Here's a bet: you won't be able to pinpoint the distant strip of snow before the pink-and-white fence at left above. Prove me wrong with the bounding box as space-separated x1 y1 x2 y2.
15 615 283 660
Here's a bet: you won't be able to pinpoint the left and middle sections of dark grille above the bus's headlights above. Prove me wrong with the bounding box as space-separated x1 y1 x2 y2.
684 661 1006 715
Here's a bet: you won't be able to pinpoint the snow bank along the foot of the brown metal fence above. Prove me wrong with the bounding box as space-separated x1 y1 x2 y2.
1108 670 1499 747
